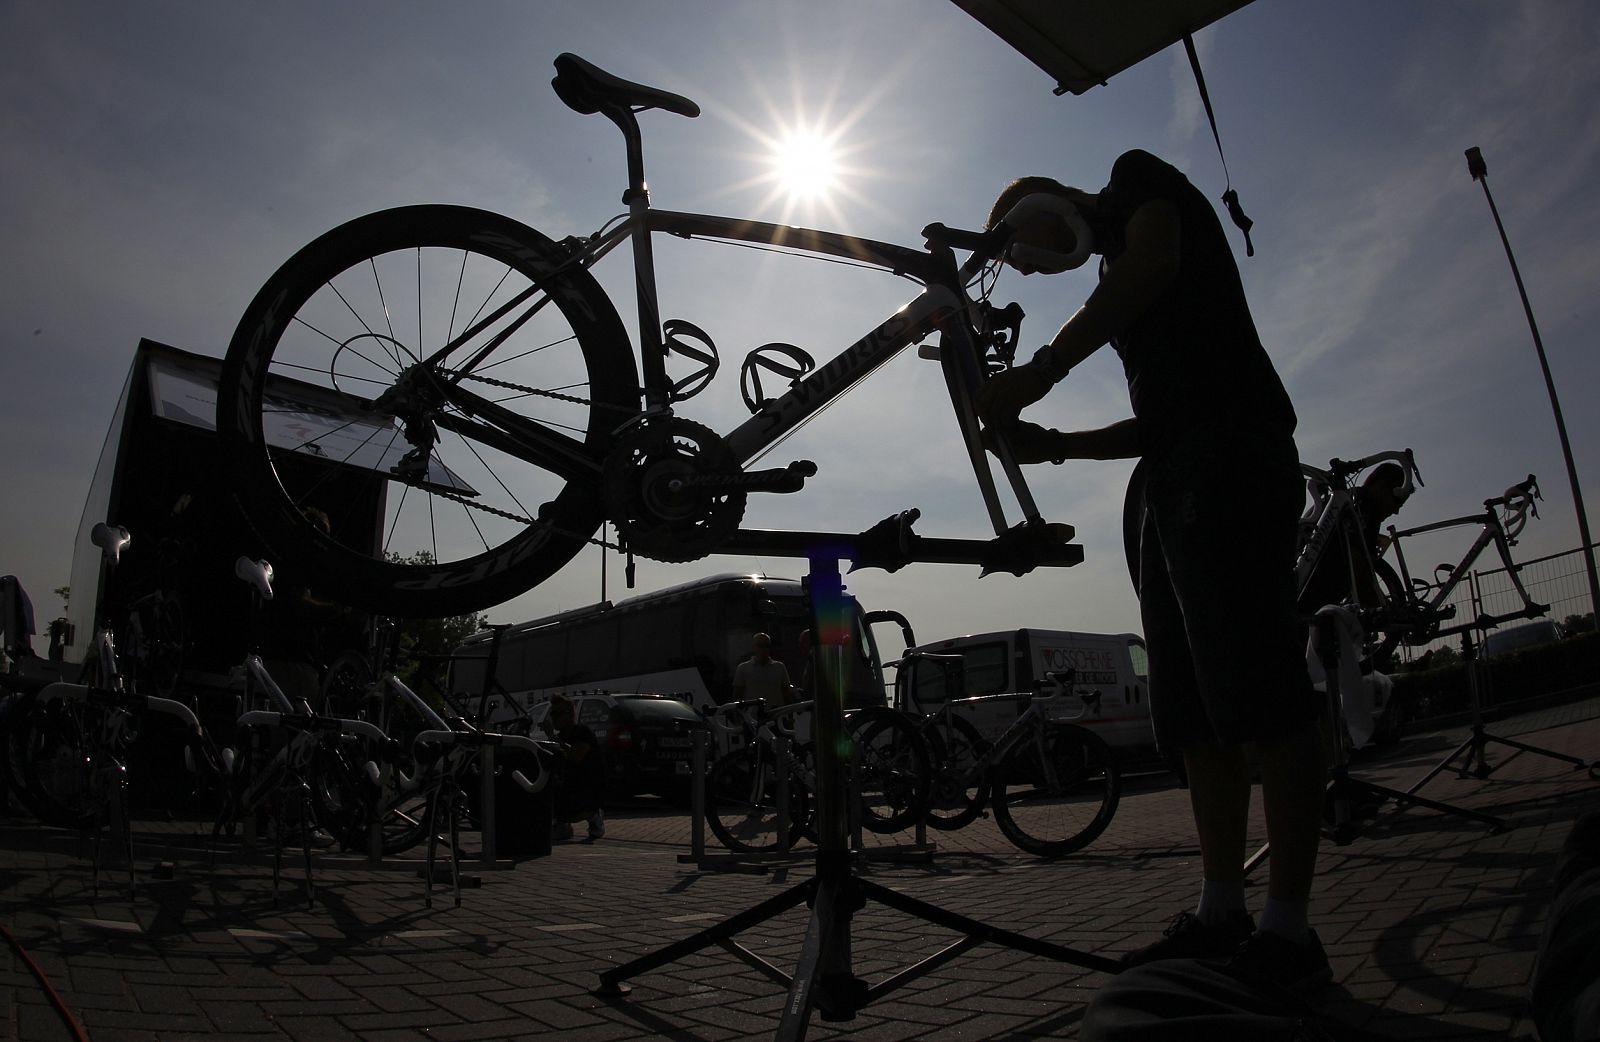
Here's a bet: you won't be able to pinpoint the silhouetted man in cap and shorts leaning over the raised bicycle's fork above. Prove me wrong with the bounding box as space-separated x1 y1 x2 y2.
979 150 1330 991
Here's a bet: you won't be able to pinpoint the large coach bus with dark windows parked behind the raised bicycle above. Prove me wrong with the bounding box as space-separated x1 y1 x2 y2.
451 575 909 720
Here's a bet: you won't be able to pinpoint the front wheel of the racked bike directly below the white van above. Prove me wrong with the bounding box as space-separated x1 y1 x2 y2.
992 723 1122 858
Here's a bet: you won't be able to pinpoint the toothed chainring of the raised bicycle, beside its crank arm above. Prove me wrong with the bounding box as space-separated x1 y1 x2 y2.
605 416 746 563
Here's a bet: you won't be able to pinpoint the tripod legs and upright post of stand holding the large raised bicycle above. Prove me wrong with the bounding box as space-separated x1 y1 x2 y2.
594 551 1122 1042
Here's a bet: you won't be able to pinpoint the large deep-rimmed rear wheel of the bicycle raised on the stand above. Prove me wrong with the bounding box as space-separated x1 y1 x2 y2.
218 206 638 618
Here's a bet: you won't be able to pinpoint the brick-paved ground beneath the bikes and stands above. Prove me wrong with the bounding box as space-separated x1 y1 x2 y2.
0 699 1600 1042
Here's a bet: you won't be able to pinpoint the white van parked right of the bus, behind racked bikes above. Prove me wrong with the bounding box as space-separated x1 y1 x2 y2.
894 629 1155 749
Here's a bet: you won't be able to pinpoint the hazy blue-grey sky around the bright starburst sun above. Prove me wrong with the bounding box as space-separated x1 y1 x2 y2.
0 0 1600 659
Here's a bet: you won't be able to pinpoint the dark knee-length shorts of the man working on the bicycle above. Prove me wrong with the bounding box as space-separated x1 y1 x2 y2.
1139 431 1323 752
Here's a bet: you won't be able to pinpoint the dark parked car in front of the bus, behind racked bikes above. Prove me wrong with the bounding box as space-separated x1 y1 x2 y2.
528 693 709 799
